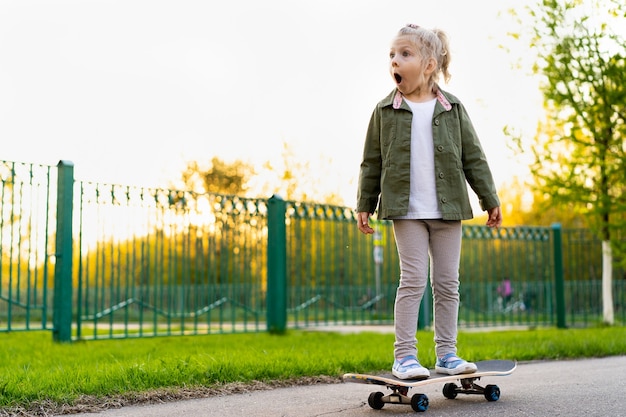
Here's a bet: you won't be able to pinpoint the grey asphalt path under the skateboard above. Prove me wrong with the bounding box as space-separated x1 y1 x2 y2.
74 352 626 417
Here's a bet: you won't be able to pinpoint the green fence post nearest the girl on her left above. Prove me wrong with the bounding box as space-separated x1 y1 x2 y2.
267 195 287 334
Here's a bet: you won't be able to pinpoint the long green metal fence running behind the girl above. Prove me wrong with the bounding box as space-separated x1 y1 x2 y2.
0 161 626 340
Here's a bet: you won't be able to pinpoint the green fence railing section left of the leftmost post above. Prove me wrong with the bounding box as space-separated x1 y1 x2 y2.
0 161 56 331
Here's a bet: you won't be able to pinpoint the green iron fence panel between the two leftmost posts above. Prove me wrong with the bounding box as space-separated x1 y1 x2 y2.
75 181 267 338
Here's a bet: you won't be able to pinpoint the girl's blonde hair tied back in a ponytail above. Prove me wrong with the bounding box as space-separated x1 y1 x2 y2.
397 23 450 91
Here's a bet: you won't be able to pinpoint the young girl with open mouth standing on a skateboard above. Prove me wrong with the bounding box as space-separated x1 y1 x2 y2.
357 25 502 379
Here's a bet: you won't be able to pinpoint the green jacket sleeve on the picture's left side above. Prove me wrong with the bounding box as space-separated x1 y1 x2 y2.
356 106 382 213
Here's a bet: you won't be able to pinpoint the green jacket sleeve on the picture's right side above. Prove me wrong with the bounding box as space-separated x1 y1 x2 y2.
459 104 500 210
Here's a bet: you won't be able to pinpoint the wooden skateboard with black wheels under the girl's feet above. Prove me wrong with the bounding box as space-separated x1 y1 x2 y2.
343 360 517 412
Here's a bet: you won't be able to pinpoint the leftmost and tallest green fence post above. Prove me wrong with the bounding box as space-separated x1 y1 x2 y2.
52 161 74 342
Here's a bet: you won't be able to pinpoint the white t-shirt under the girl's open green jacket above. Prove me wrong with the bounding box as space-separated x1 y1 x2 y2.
395 98 443 219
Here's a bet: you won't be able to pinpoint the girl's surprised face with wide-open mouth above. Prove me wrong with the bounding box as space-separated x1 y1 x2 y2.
389 36 436 101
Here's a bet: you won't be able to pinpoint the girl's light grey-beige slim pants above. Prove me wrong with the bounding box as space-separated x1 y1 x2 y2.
393 220 462 358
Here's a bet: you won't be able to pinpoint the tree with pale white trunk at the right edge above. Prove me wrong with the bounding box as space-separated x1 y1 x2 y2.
516 0 626 324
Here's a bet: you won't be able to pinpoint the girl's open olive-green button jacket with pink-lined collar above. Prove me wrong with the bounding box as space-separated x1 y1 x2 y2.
357 89 500 220
